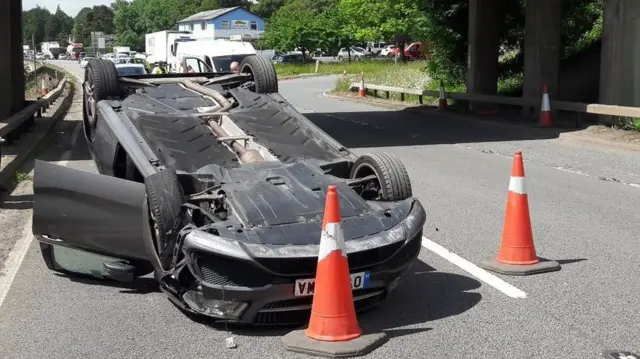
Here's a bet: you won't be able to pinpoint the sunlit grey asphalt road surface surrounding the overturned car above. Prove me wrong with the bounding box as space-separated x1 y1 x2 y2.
0 61 640 359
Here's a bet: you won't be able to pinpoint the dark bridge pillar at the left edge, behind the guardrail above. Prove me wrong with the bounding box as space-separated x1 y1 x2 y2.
0 0 24 120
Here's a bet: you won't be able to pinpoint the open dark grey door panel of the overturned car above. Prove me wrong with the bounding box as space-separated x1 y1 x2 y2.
32 160 151 260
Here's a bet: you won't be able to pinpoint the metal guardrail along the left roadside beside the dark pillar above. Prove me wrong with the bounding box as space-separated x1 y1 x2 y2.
0 75 67 155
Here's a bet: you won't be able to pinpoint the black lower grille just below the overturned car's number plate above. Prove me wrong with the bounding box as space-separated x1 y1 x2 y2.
253 288 386 324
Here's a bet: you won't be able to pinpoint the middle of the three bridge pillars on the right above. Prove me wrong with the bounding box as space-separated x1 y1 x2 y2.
523 0 562 115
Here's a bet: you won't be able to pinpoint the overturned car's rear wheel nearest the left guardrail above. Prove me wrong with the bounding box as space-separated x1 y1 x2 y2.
82 60 120 140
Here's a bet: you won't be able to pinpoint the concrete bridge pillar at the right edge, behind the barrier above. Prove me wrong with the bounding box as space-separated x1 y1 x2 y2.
600 0 640 124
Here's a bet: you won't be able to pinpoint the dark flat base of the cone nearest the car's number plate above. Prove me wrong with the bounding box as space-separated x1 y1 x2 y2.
282 329 389 358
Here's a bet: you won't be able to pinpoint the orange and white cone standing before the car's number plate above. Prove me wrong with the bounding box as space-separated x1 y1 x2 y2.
282 185 388 358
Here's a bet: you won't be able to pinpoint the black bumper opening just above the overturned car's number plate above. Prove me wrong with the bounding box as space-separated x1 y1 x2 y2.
255 242 403 275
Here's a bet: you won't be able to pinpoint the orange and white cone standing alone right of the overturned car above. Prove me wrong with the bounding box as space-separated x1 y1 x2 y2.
480 151 560 275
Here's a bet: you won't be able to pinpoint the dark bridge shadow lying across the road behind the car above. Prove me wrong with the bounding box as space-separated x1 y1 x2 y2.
304 107 592 148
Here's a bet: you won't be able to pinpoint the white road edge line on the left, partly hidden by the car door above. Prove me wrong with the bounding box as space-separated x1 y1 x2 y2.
0 123 82 307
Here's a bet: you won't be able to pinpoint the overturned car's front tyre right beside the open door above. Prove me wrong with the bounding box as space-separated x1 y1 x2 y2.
144 169 184 269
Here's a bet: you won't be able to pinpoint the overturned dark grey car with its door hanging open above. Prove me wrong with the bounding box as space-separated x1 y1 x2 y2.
33 55 425 324
